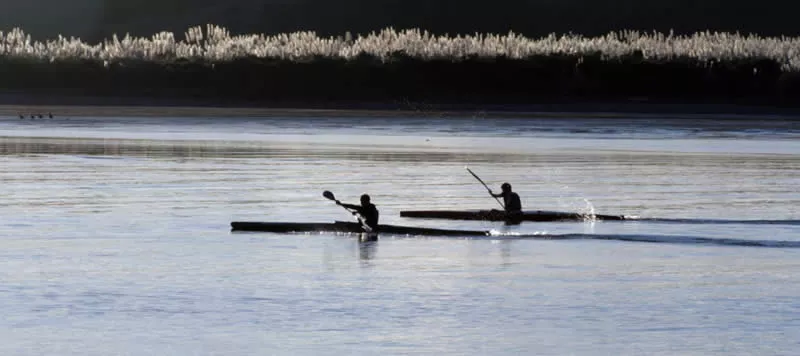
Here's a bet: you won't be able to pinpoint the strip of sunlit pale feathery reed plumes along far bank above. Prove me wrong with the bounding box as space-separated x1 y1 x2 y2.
0 25 800 71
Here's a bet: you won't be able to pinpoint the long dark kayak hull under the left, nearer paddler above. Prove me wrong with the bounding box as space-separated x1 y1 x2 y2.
231 221 489 236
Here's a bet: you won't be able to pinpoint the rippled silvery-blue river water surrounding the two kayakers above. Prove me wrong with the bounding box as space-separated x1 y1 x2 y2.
0 114 800 355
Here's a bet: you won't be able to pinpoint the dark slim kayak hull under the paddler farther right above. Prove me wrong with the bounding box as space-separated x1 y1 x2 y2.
400 210 625 221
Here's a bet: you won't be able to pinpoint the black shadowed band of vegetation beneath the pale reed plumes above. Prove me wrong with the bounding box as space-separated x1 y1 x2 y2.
0 53 800 107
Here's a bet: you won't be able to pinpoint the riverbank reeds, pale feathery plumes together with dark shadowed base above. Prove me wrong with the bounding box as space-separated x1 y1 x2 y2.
0 25 800 105
